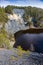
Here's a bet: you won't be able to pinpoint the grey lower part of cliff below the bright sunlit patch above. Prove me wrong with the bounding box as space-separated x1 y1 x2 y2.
5 19 25 34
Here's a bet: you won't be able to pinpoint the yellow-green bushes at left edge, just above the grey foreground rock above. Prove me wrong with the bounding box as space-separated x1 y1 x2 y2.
0 33 10 49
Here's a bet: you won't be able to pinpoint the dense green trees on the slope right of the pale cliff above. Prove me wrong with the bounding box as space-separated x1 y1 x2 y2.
23 6 43 26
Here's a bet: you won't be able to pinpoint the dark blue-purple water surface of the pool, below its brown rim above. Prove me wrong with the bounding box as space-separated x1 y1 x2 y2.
14 33 43 53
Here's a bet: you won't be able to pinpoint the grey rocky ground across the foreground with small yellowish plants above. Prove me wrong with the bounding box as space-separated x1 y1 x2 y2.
0 48 43 65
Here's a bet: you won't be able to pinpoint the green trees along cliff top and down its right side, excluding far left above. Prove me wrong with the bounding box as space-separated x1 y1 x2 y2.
5 5 43 27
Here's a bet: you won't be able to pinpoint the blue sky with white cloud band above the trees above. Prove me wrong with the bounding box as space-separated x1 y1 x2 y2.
0 0 43 8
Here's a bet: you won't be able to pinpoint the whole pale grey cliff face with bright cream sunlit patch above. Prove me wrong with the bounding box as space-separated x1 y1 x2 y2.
5 9 28 34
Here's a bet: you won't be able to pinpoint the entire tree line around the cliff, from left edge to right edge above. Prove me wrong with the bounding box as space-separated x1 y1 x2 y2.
0 5 43 26
